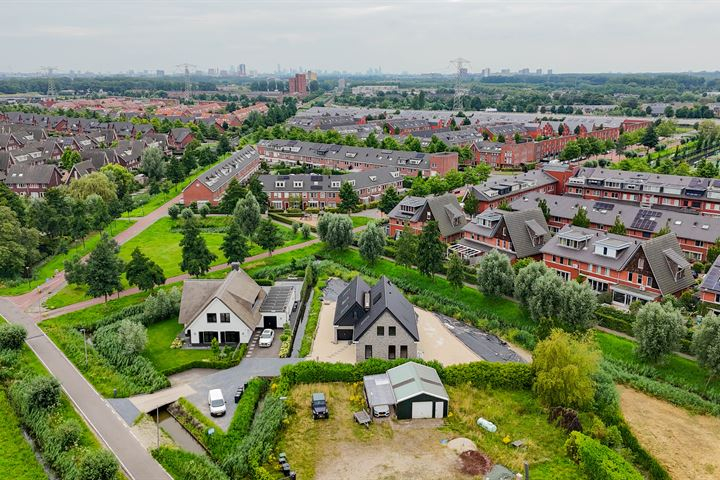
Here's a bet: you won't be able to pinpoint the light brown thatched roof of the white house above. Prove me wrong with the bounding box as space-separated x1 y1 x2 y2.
178 269 266 329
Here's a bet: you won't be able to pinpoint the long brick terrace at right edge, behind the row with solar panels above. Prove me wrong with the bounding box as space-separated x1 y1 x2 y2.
565 168 720 215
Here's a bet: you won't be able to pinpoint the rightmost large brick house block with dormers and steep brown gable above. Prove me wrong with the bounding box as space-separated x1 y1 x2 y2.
541 226 694 308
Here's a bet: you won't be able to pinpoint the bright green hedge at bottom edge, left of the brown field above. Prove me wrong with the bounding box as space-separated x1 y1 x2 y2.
565 432 644 480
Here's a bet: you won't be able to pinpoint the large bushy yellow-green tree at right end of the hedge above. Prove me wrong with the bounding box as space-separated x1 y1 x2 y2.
533 330 600 409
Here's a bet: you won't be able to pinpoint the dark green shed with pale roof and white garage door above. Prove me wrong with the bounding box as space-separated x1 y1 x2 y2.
387 362 450 419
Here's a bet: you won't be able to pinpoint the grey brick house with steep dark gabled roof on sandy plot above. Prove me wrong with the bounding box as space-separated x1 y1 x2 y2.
333 276 420 362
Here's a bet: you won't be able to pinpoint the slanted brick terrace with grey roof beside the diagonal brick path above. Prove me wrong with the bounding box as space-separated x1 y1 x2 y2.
183 146 260 206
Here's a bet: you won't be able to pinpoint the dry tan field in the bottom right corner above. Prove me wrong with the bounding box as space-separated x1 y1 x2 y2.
618 386 720 480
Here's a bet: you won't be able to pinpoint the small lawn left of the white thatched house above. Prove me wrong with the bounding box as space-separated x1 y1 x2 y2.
142 317 213 372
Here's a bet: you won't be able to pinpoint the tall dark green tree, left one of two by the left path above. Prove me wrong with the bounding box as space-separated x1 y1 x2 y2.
84 232 124 302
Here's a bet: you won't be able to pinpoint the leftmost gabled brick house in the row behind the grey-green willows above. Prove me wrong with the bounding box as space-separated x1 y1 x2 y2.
388 193 467 242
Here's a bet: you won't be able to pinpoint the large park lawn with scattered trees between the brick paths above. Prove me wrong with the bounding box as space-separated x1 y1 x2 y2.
45 217 306 309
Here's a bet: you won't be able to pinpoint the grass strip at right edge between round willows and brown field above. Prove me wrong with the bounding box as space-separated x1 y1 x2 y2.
595 332 720 395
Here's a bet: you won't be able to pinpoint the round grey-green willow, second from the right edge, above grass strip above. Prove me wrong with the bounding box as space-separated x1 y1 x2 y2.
633 302 685 362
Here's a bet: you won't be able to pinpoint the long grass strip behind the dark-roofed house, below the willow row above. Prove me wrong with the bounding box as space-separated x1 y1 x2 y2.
322 249 534 327
